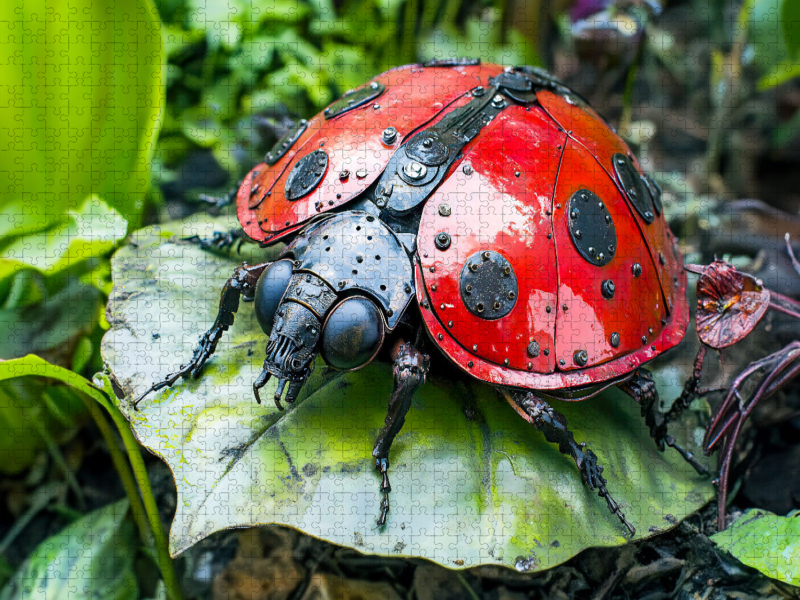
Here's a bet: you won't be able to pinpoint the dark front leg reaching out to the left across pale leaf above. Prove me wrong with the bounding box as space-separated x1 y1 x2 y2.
133 262 271 410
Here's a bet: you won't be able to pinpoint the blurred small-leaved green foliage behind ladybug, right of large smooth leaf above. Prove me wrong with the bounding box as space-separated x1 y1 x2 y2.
155 0 536 182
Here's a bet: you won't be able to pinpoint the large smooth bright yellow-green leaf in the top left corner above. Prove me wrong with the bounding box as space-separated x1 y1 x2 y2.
0 0 164 232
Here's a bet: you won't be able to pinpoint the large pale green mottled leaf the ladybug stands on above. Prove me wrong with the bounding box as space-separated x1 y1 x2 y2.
102 218 712 569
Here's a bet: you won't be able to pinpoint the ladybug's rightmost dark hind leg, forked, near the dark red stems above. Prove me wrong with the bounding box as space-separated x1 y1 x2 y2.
619 368 708 475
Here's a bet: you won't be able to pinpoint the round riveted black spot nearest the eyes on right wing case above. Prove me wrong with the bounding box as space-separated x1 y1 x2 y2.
461 250 519 321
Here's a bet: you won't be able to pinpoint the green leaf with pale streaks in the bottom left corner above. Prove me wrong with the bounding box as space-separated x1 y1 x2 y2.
0 499 138 600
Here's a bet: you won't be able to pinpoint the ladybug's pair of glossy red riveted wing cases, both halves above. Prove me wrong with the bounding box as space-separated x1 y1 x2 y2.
238 65 689 390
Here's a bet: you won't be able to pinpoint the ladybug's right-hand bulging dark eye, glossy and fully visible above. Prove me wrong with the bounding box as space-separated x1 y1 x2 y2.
322 296 386 371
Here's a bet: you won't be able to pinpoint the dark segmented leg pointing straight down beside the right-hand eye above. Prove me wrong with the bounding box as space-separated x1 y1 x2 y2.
372 341 430 525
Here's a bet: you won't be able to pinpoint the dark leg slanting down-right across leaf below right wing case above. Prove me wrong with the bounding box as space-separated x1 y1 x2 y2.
501 389 636 535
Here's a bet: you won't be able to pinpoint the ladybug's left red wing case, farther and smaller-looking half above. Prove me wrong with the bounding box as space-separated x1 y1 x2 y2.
237 65 502 243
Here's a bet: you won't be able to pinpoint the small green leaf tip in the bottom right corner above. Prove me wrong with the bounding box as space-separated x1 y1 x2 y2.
711 508 800 586
